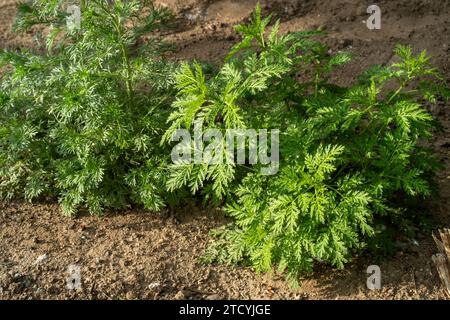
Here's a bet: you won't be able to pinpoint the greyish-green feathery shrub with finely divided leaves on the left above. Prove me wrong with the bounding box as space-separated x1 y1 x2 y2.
0 0 174 214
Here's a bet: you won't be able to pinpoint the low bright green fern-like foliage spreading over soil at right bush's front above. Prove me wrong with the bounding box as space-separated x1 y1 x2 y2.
205 146 373 283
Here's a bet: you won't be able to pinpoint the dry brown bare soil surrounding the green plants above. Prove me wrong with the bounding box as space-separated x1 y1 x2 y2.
0 0 450 299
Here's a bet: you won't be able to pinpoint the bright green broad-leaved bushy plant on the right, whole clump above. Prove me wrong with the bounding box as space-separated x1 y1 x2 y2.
164 6 448 282
